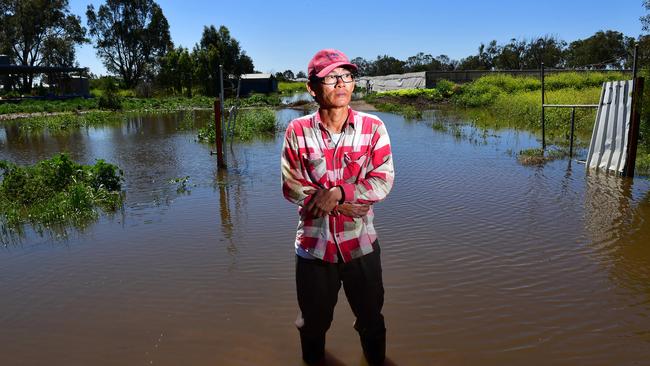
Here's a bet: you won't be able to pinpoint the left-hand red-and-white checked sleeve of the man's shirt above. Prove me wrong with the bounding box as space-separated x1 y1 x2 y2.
281 125 318 206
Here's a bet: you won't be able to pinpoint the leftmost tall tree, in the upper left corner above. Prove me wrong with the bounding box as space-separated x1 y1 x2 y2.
0 0 88 91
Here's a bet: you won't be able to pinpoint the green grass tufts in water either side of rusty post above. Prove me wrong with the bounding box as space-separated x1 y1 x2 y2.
197 108 278 143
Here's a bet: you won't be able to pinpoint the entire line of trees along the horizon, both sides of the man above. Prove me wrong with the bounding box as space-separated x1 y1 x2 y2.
0 0 650 95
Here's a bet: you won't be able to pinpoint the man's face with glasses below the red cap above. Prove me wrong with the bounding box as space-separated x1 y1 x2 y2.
307 67 354 108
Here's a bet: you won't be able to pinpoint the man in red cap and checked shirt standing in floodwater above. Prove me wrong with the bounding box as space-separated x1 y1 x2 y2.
282 49 394 365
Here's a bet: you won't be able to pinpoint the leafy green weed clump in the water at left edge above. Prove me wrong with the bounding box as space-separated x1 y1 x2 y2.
0 154 123 240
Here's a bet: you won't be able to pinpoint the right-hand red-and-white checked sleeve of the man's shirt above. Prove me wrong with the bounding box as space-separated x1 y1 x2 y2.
341 123 395 204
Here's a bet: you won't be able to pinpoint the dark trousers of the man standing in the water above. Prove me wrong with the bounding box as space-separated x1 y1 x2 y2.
296 241 386 364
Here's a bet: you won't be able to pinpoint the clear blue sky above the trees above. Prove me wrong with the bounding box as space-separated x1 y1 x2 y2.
69 0 647 75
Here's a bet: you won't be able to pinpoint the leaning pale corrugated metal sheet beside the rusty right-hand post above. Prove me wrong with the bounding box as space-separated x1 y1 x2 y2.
587 80 633 173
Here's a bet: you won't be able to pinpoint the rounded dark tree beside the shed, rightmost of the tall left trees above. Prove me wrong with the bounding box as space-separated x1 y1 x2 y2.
192 25 254 96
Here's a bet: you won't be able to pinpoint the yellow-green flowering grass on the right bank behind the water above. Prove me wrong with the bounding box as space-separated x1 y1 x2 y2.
364 70 650 175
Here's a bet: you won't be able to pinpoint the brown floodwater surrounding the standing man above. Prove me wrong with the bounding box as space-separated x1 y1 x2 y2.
0 109 650 366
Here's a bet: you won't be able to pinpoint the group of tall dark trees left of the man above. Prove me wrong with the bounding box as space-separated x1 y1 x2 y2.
0 0 254 95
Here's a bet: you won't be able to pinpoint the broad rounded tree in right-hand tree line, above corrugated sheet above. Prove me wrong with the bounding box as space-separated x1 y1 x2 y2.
564 30 634 69
